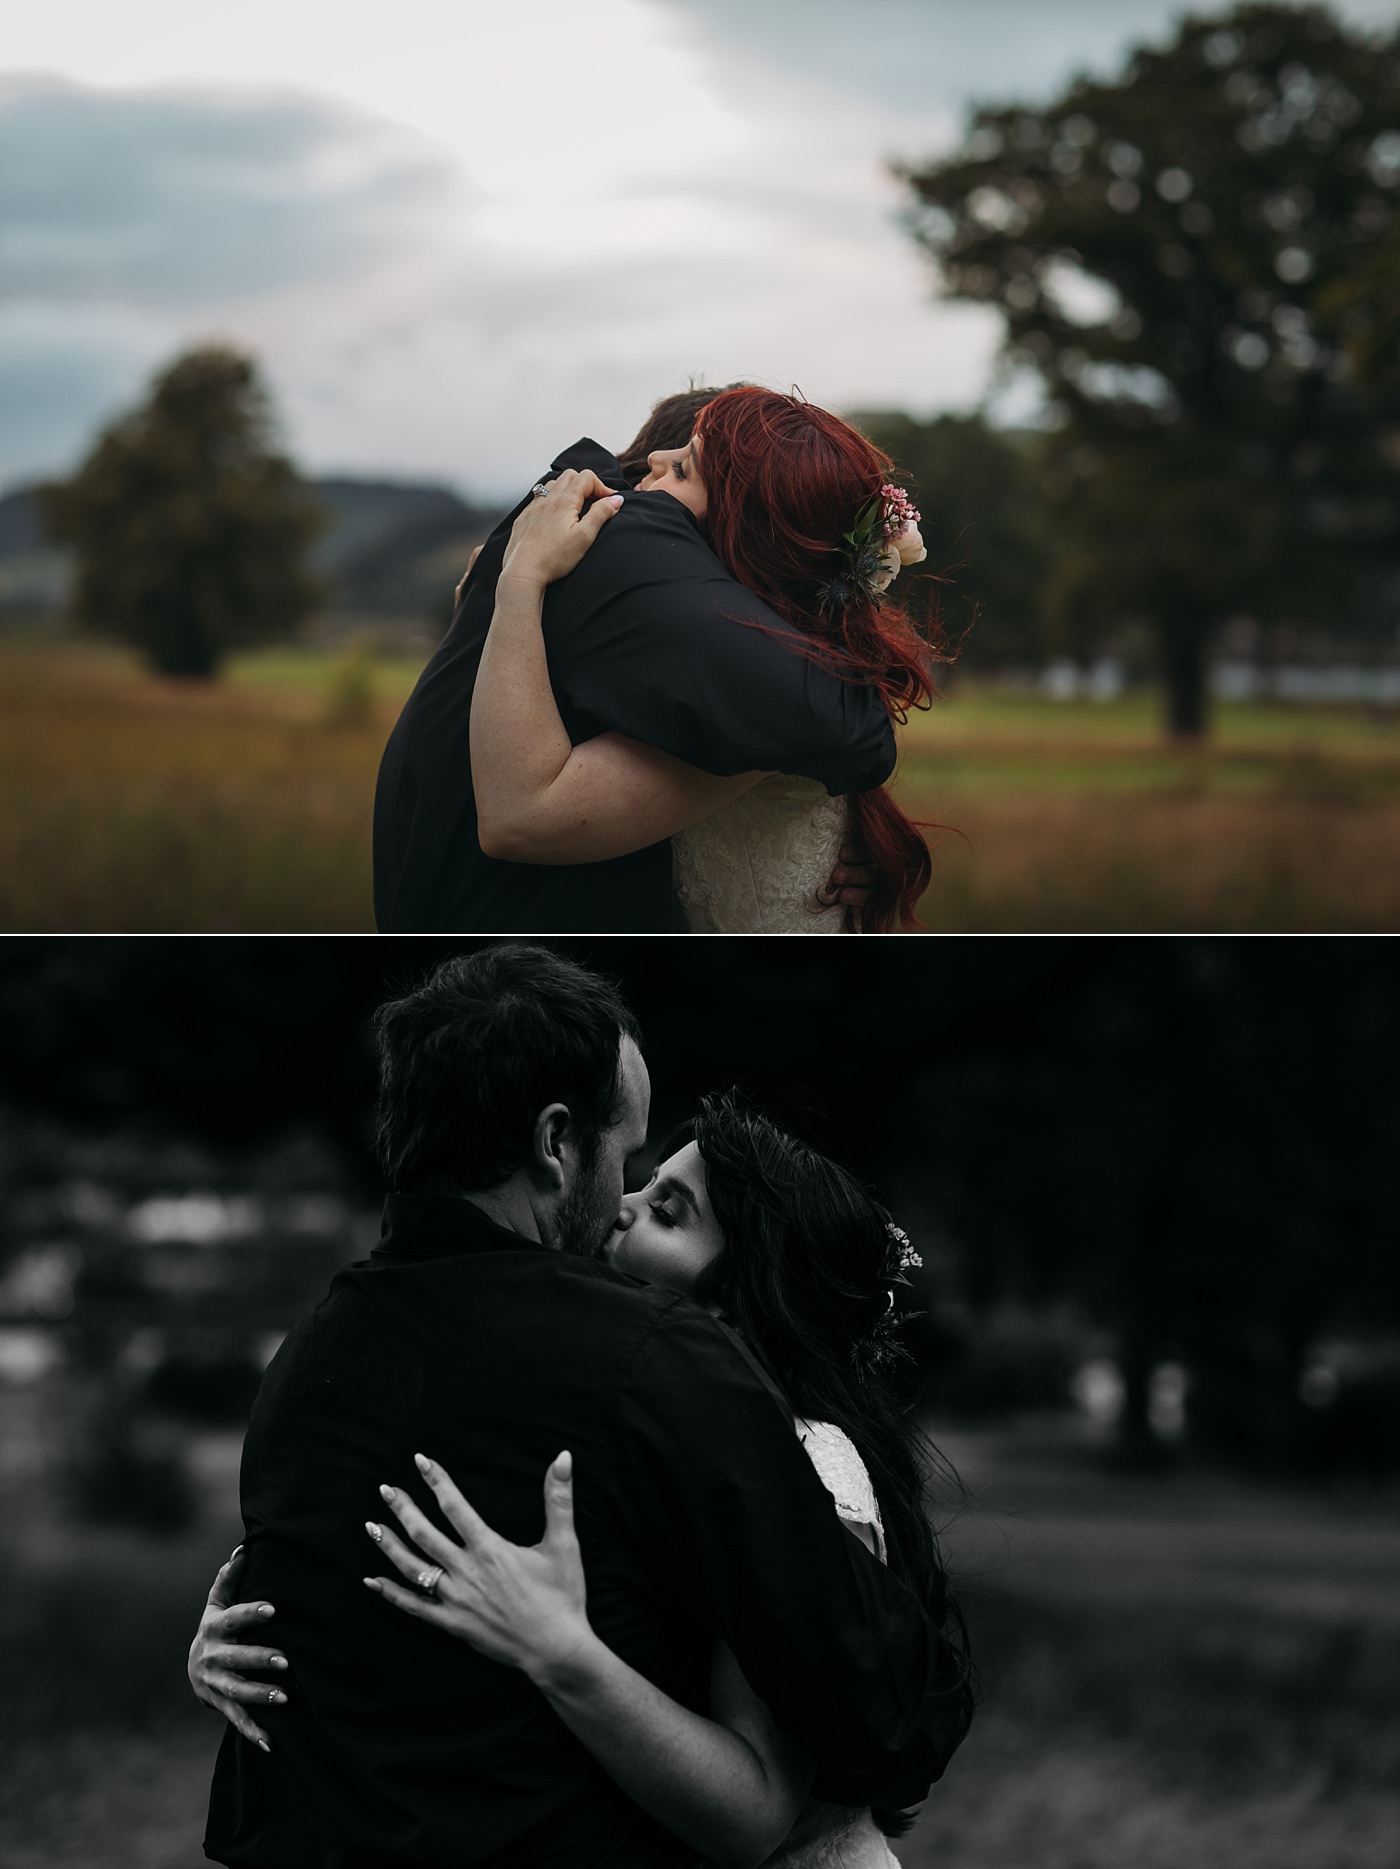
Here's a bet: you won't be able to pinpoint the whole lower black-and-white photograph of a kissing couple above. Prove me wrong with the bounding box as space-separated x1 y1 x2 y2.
0 938 1400 1869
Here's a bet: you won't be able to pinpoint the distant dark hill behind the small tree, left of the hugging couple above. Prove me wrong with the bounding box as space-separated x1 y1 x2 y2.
0 475 501 624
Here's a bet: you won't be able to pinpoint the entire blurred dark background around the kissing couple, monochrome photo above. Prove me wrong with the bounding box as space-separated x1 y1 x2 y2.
0 938 1400 1869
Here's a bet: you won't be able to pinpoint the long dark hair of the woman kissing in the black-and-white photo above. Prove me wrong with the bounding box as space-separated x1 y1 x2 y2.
680 1091 974 1835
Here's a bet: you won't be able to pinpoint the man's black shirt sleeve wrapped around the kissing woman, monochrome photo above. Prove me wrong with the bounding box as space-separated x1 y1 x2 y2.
601 1303 968 1805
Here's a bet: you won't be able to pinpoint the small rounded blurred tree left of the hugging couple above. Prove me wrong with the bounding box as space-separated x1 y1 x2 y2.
43 346 323 677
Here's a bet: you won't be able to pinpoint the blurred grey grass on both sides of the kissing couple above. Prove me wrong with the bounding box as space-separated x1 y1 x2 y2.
0 1420 1400 1869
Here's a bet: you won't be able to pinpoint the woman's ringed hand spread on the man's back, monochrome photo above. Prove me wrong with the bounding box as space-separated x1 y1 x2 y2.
364 1454 594 1684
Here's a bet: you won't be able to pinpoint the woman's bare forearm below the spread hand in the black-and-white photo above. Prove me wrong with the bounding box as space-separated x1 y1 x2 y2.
531 1635 811 1865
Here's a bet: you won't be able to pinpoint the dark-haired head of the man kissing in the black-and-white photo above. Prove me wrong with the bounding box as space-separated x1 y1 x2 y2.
374 946 650 1252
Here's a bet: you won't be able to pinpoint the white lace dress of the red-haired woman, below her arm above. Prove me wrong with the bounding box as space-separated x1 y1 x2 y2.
671 772 847 935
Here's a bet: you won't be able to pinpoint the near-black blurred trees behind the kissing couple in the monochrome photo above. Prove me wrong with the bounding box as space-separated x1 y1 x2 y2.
0 938 1400 1471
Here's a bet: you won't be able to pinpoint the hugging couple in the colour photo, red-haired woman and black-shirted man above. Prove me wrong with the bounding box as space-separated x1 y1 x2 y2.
374 385 933 935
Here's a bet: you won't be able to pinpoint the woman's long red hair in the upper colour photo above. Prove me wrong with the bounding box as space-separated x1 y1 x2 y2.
695 387 935 933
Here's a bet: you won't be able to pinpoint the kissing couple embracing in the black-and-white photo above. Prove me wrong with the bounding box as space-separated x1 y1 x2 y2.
191 946 972 1869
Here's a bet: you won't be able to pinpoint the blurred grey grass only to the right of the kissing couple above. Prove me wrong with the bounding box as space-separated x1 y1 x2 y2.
899 1417 1400 1869
